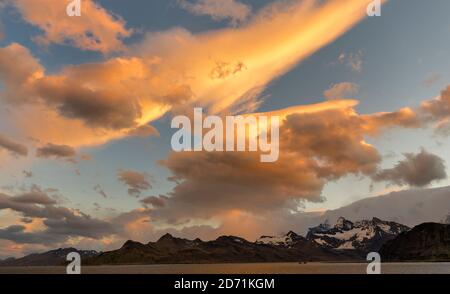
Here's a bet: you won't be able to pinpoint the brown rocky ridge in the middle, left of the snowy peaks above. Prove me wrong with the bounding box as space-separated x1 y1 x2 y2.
87 232 355 265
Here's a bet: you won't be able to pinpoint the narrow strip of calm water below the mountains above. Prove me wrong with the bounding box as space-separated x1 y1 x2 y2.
0 263 450 274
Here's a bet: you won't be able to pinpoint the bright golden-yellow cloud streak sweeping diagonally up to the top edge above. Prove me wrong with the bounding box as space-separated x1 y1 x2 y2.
136 0 380 113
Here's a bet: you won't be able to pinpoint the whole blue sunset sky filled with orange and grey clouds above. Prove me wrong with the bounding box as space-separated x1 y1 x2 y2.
0 0 450 258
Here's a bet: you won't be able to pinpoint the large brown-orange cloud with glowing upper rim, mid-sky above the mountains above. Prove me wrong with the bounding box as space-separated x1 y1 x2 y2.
147 100 391 224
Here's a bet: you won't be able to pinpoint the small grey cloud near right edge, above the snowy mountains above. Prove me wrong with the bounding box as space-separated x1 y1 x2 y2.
372 149 447 187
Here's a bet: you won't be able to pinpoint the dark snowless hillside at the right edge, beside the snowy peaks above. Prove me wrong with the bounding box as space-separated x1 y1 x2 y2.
380 223 450 261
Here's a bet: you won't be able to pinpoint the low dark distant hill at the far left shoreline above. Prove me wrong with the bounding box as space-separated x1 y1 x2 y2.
0 248 99 266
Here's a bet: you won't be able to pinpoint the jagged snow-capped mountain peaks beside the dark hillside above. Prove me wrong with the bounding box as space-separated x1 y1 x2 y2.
307 217 410 254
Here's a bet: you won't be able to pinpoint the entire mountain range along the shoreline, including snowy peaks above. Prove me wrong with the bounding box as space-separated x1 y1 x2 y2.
0 217 450 266
